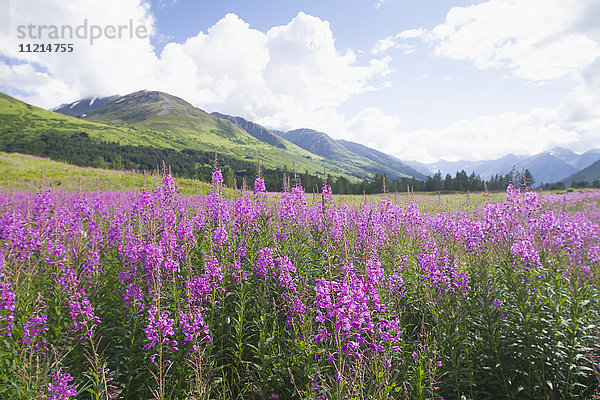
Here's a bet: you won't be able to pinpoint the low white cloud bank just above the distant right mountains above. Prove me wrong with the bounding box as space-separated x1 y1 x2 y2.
332 104 600 162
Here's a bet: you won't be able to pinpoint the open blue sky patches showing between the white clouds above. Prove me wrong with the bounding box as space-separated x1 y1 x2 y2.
152 0 571 130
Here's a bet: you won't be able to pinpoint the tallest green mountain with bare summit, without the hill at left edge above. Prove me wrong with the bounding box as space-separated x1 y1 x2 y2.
76 91 384 181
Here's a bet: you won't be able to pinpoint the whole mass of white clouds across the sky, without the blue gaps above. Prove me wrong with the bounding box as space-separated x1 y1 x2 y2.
0 0 600 161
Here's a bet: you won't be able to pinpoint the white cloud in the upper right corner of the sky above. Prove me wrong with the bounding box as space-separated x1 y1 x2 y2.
425 0 600 81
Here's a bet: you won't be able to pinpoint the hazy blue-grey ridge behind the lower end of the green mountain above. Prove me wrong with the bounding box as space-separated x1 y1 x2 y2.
278 128 425 179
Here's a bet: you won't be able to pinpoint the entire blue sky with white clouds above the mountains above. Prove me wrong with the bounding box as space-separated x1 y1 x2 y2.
0 0 600 162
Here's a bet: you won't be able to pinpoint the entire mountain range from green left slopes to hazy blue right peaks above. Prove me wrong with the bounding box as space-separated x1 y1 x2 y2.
5 91 600 185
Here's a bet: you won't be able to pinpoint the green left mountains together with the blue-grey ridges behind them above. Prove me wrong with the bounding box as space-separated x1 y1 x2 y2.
0 91 425 182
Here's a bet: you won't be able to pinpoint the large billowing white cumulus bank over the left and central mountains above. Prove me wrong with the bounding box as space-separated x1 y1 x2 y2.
0 0 390 134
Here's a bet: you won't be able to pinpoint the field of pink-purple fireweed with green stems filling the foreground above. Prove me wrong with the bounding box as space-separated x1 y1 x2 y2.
0 169 600 400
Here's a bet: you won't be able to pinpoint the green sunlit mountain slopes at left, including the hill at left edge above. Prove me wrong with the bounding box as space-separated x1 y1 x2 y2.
0 91 352 182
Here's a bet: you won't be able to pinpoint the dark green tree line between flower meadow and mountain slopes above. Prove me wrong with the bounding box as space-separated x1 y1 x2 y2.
0 131 535 194
